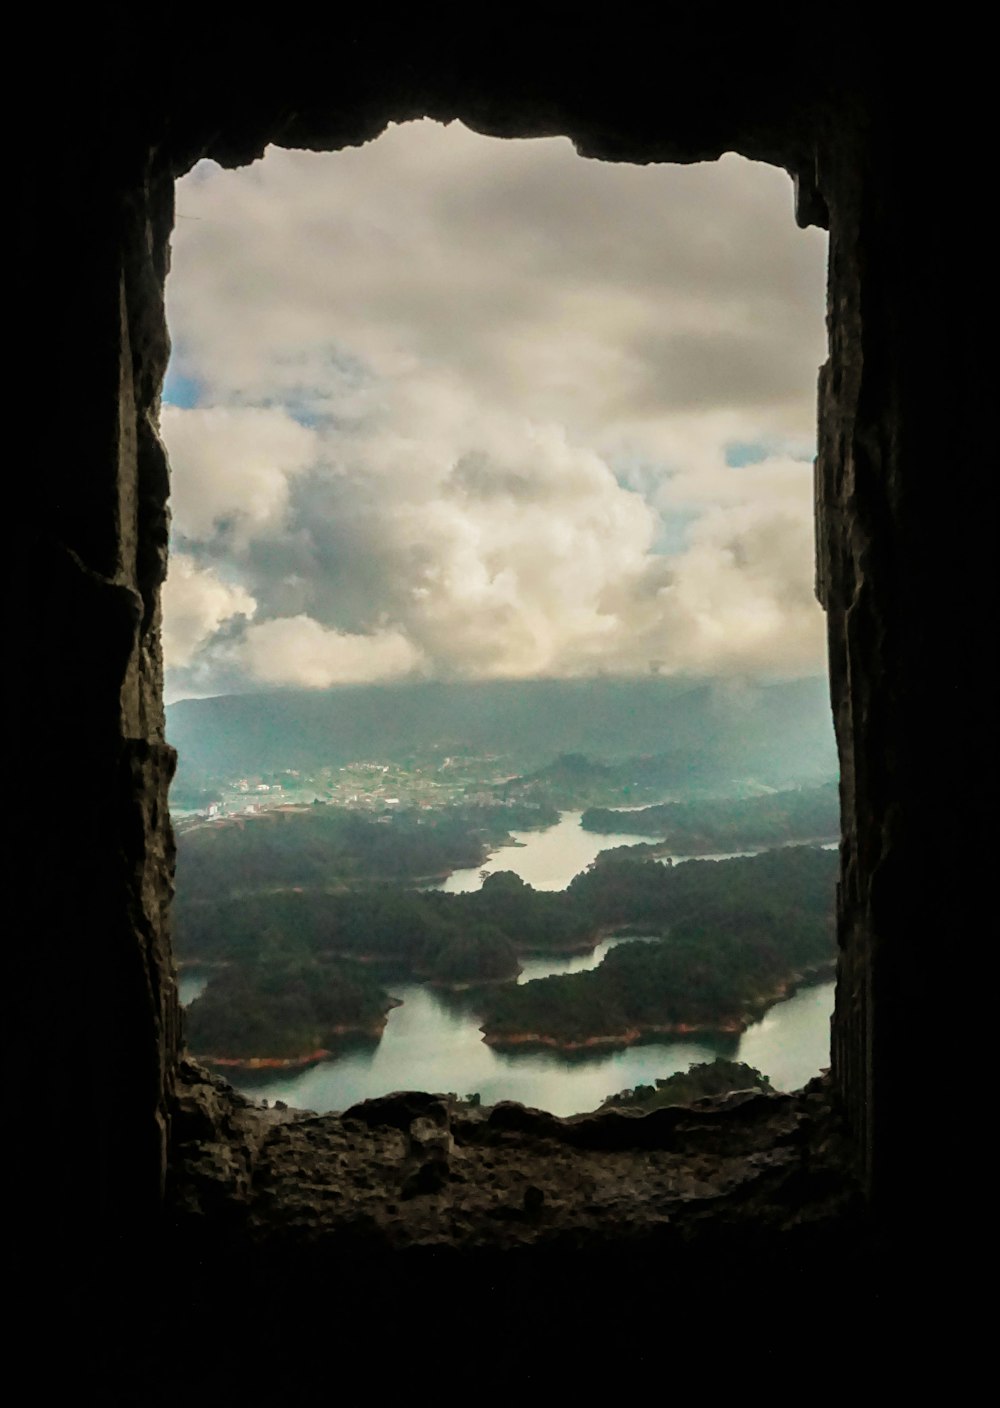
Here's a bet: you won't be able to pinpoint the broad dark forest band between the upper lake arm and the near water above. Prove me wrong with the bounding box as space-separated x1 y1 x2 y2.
176 846 837 1056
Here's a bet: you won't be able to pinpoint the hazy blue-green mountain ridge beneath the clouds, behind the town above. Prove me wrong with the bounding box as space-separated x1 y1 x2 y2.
168 677 837 786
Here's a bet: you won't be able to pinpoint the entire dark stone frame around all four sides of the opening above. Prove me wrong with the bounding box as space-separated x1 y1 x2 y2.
19 24 992 1401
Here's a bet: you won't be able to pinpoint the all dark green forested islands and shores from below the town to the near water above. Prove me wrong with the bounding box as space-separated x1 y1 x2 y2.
176 804 837 1069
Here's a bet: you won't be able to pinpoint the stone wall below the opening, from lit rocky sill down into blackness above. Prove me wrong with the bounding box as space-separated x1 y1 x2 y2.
152 1063 885 1385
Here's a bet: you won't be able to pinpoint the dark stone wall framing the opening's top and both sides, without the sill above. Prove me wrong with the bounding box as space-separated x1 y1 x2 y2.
10 19 987 1317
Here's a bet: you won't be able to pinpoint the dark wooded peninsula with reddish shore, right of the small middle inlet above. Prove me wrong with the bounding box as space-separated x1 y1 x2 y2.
483 846 837 1048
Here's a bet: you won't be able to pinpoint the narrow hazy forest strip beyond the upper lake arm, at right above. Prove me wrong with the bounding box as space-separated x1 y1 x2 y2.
580 783 841 856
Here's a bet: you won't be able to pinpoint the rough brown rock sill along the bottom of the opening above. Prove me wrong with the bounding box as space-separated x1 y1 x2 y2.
170 1064 863 1257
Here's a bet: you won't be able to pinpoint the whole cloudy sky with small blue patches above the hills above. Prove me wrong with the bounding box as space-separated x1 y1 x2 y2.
162 121 827 698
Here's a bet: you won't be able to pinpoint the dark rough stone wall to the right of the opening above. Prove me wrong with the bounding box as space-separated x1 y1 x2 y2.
817 90 996 1210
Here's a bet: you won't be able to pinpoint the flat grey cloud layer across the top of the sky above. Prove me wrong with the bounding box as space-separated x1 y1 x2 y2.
169 130 824 435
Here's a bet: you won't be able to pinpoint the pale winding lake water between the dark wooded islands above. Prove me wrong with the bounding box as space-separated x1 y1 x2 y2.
180 812 834 1115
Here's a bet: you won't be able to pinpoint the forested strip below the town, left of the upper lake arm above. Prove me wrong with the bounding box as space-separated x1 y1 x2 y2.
177 804 559 900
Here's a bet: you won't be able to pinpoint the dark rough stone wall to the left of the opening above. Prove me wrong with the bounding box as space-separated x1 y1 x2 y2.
16 140 180 1284
